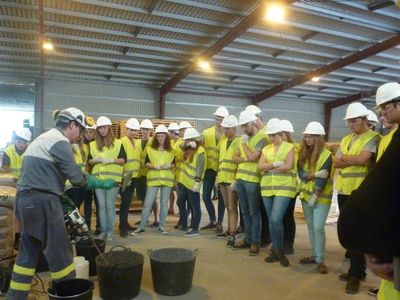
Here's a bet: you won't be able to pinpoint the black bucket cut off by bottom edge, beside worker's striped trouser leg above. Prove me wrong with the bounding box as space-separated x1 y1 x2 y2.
47 278 94 300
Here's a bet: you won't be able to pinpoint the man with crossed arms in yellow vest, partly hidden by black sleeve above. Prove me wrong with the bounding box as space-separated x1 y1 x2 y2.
334 102 379 294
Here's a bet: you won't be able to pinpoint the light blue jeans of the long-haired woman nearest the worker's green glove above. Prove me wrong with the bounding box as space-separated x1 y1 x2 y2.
96 187 118 235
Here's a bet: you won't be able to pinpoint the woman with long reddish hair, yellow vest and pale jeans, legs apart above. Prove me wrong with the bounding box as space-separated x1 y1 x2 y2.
132 125 175 236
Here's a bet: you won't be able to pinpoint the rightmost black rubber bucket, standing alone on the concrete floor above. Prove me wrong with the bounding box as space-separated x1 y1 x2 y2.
147 248 199 296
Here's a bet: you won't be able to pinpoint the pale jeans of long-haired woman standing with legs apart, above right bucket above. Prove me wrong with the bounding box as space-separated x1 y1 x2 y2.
140 185 172 229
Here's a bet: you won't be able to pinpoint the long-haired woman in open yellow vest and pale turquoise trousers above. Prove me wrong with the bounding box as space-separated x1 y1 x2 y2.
298 122 333 274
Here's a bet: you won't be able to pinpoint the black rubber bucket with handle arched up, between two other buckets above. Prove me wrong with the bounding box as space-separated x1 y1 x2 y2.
96 246 144 300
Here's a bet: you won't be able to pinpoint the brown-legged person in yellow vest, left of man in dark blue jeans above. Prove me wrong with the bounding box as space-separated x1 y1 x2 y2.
217 115 240 247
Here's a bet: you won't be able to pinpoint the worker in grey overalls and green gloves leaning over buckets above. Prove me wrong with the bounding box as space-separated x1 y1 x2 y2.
7 107 115 300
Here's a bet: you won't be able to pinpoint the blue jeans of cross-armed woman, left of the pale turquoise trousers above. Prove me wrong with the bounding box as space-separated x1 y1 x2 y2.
263 196 290 251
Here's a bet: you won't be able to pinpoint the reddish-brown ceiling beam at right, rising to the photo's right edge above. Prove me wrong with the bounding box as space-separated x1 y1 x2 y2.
252 34 400 104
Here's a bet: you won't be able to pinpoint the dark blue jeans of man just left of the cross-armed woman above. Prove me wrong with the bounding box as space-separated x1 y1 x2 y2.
236 179 261 245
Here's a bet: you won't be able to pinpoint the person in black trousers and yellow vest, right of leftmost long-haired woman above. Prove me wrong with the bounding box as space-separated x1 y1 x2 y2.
119 118 141 237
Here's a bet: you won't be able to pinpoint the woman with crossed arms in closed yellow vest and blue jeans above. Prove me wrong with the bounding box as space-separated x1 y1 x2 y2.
258 120 296 267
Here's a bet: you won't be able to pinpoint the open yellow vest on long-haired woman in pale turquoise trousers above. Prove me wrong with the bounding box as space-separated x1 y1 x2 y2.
300 148 333 205
